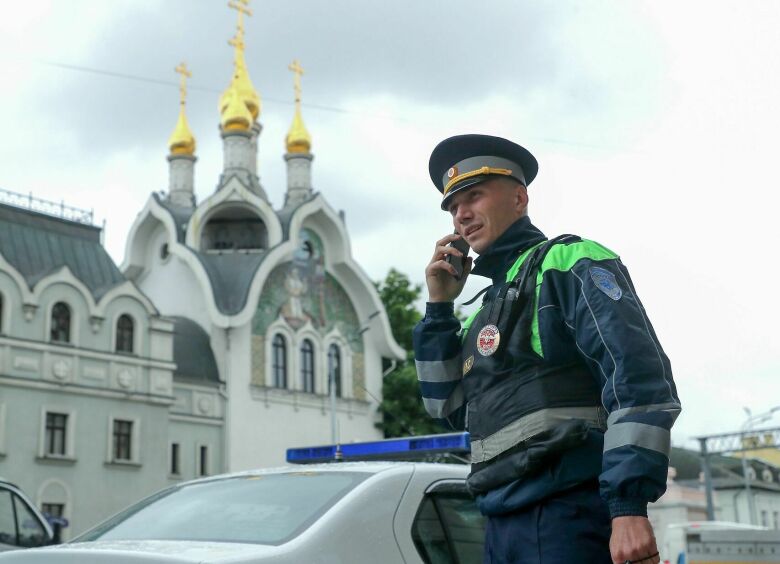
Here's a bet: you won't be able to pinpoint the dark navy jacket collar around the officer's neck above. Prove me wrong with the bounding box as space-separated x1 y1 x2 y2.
471 216 547 284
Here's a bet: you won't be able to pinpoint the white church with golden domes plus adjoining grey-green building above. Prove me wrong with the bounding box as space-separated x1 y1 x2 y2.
0 0 405 538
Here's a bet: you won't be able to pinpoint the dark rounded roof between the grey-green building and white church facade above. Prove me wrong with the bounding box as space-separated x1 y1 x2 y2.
171 317 220 385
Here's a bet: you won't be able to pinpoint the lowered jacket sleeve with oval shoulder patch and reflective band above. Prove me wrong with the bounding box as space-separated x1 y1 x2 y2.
556 253 680 518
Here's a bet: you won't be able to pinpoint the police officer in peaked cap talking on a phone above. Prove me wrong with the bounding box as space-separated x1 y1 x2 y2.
414 135 680 564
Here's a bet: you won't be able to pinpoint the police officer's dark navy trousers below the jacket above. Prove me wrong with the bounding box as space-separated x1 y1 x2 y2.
484 483 612 564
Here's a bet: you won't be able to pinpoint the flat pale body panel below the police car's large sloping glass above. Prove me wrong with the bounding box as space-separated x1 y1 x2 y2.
3 540 279 564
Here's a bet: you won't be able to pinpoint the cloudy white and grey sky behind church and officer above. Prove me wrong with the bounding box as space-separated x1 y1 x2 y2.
0 0 780 446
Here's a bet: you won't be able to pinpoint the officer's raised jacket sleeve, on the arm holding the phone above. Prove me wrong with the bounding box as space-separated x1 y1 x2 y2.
412 302 466 430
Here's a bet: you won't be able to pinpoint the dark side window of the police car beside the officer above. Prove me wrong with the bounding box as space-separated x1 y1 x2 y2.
412 491 485 564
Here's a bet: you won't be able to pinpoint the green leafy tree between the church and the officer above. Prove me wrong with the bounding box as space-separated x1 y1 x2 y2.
376 268 442 437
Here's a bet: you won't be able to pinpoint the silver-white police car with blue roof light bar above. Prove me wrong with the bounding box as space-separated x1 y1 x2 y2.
0 433 484 564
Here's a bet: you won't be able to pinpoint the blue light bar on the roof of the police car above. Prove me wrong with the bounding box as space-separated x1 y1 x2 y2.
287 433 471 464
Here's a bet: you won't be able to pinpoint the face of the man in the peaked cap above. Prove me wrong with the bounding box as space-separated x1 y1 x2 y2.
447 178 528 254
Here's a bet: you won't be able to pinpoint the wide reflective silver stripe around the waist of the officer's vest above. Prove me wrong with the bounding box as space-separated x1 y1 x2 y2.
471 407 604 463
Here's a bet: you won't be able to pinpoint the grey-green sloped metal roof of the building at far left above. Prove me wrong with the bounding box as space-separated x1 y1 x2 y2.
0 204 125 300
